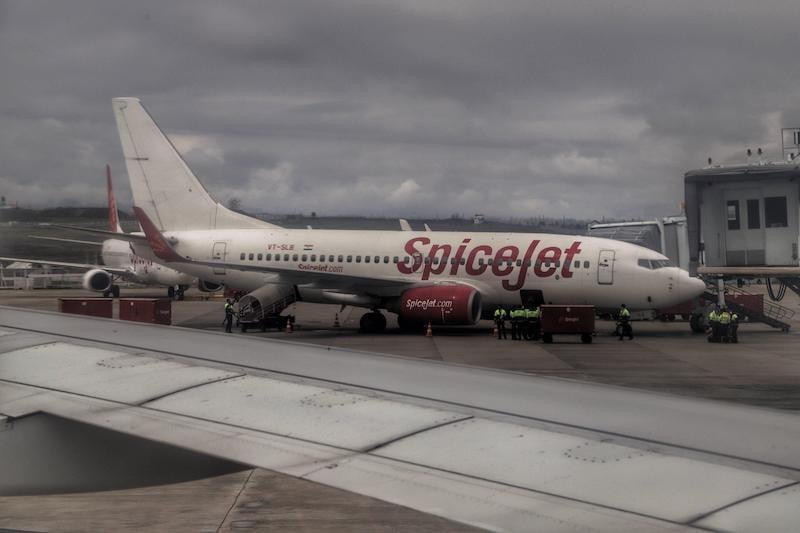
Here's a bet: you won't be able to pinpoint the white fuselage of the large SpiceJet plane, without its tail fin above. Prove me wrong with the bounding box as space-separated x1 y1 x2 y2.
137 229 702 309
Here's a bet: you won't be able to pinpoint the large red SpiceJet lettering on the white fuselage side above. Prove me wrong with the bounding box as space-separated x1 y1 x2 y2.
397 237 581 291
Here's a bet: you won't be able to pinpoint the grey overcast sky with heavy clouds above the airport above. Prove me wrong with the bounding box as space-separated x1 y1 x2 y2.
0 0 800 219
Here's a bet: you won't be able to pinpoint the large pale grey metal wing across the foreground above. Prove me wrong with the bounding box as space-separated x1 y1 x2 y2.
0 307 800 532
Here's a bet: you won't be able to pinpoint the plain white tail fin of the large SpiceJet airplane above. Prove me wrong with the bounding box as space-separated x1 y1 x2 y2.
112 98 277 231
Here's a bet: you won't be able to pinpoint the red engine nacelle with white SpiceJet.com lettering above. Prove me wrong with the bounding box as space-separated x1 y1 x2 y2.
388 285 481 326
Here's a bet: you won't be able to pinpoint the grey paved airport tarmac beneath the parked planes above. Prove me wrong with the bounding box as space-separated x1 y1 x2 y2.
0 288 800 531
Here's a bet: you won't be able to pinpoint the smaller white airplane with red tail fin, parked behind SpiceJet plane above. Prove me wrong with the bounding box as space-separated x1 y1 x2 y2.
0 165 206 298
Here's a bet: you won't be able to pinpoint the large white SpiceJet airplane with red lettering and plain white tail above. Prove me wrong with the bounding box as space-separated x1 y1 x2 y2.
113 98 705 331
